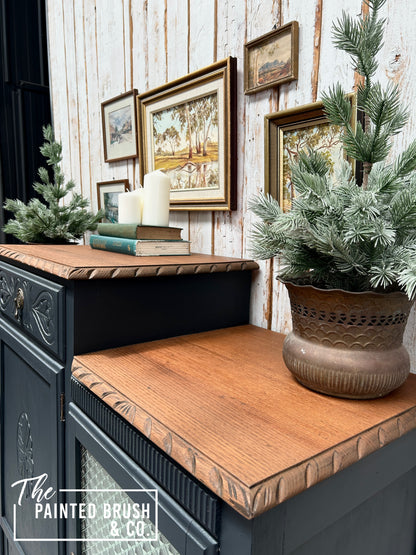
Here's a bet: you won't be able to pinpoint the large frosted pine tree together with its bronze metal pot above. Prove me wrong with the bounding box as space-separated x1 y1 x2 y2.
250 0 416 399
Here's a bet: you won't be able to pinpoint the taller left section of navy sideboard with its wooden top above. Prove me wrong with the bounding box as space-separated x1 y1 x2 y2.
0 245 257 555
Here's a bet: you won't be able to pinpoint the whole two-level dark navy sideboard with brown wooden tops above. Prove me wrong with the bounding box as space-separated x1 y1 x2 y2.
0 245 416 555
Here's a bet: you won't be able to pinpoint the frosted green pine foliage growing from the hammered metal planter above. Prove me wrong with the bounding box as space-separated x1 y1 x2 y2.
250 0 416 299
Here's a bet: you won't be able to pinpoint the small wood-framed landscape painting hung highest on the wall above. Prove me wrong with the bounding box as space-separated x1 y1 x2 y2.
244 21 299 94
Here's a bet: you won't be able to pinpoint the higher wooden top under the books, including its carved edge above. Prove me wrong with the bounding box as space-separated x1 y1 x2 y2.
0 244 258 280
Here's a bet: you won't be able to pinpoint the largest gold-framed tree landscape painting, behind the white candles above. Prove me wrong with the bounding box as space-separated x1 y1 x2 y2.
137 57 237 210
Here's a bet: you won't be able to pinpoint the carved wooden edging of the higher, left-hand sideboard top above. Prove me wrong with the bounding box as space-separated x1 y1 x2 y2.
0 246 259 280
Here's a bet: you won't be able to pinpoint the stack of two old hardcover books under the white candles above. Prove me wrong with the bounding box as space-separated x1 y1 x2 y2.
90 223 191 256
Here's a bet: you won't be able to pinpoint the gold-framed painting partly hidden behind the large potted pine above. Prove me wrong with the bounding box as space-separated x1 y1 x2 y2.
265 94 360 211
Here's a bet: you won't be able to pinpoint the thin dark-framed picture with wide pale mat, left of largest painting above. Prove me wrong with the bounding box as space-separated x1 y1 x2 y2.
101 89 137 162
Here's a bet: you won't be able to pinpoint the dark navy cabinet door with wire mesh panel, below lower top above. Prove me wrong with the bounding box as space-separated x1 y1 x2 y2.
67 403 218 555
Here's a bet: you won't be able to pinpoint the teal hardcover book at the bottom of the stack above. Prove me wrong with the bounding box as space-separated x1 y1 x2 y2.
90 235 191 256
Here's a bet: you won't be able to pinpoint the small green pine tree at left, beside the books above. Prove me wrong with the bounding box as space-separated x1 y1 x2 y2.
3 125 103 243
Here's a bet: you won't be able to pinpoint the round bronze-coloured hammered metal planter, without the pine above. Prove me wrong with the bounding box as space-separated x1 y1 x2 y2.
283 282 413 399
